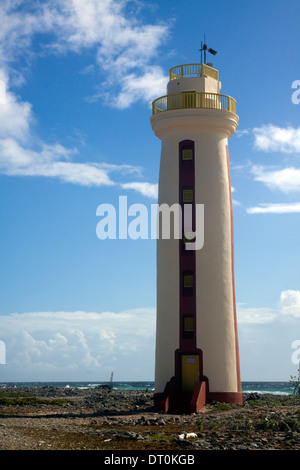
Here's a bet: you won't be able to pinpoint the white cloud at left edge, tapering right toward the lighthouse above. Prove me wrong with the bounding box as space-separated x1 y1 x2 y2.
0 76 149 186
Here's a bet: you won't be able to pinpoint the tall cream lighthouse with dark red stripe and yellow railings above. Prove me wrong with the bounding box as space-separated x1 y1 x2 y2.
150 57 242 412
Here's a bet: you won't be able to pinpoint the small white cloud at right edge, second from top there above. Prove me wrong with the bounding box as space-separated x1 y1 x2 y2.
251 165 300 192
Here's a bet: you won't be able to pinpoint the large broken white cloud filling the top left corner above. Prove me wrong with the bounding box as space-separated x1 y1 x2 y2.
0 0 169 108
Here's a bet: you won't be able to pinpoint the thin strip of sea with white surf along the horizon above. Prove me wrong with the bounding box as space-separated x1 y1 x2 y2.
0 381 293 395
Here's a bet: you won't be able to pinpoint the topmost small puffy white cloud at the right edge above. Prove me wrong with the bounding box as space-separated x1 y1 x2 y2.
253 124 300 153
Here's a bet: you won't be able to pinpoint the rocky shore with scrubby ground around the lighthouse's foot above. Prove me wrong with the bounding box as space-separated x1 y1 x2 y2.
0 386 300 451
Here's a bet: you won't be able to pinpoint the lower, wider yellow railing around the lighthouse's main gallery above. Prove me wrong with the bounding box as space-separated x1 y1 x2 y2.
152 92 236 115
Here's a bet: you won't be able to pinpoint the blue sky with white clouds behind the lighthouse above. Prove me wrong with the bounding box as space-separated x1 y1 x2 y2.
0 0 300 382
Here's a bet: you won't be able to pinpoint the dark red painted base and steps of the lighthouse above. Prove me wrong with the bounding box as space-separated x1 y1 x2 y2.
154 376 243 414
